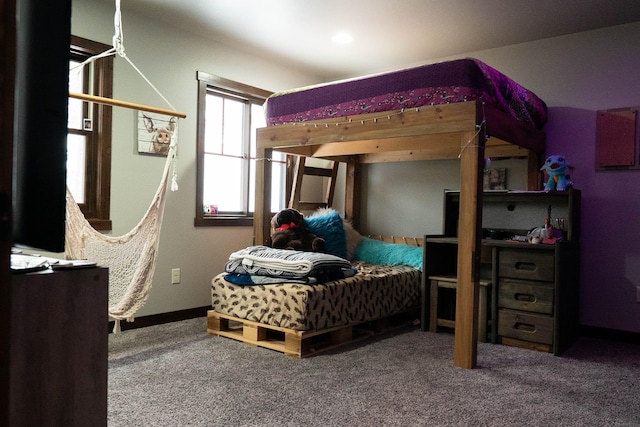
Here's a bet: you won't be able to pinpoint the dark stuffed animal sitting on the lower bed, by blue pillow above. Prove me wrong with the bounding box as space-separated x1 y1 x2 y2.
271 209 324 252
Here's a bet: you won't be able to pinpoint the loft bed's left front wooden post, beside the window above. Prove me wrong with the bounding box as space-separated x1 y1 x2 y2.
253 140 273 246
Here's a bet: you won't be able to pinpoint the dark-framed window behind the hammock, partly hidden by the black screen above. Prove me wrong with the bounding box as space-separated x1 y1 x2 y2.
67 36 113 230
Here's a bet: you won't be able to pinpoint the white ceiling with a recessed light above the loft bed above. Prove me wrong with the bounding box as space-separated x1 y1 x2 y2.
120 0 640 80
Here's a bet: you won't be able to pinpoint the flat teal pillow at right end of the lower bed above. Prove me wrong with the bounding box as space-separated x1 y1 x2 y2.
354 237 422 270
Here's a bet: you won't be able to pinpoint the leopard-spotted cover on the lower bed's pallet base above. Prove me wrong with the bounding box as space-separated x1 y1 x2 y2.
211 261 421 330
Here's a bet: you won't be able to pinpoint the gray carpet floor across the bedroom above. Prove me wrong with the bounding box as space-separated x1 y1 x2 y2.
108 318 640 427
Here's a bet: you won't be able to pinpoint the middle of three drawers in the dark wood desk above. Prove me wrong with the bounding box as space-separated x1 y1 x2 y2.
498 278 554 314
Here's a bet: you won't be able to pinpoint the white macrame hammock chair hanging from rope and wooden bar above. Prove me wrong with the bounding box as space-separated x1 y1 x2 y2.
65 0 186 332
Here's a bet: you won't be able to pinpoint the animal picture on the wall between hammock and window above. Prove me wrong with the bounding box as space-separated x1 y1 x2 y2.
137 111 178 157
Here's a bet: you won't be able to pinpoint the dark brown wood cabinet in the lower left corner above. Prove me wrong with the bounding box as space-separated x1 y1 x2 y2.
9 268 109 426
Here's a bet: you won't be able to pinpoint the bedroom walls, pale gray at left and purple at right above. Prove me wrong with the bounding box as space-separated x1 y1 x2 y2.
72 0 640 332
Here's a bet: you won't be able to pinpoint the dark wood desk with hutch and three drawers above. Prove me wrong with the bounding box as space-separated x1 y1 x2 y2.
422 189 581 355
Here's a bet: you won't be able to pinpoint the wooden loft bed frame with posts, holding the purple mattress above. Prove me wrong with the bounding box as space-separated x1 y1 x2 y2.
254 101 546 368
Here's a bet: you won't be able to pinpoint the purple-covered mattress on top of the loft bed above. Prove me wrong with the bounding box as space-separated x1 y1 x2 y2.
266 59 547 129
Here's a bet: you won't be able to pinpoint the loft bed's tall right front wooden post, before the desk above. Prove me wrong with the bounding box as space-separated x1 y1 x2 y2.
453 129 485 369
